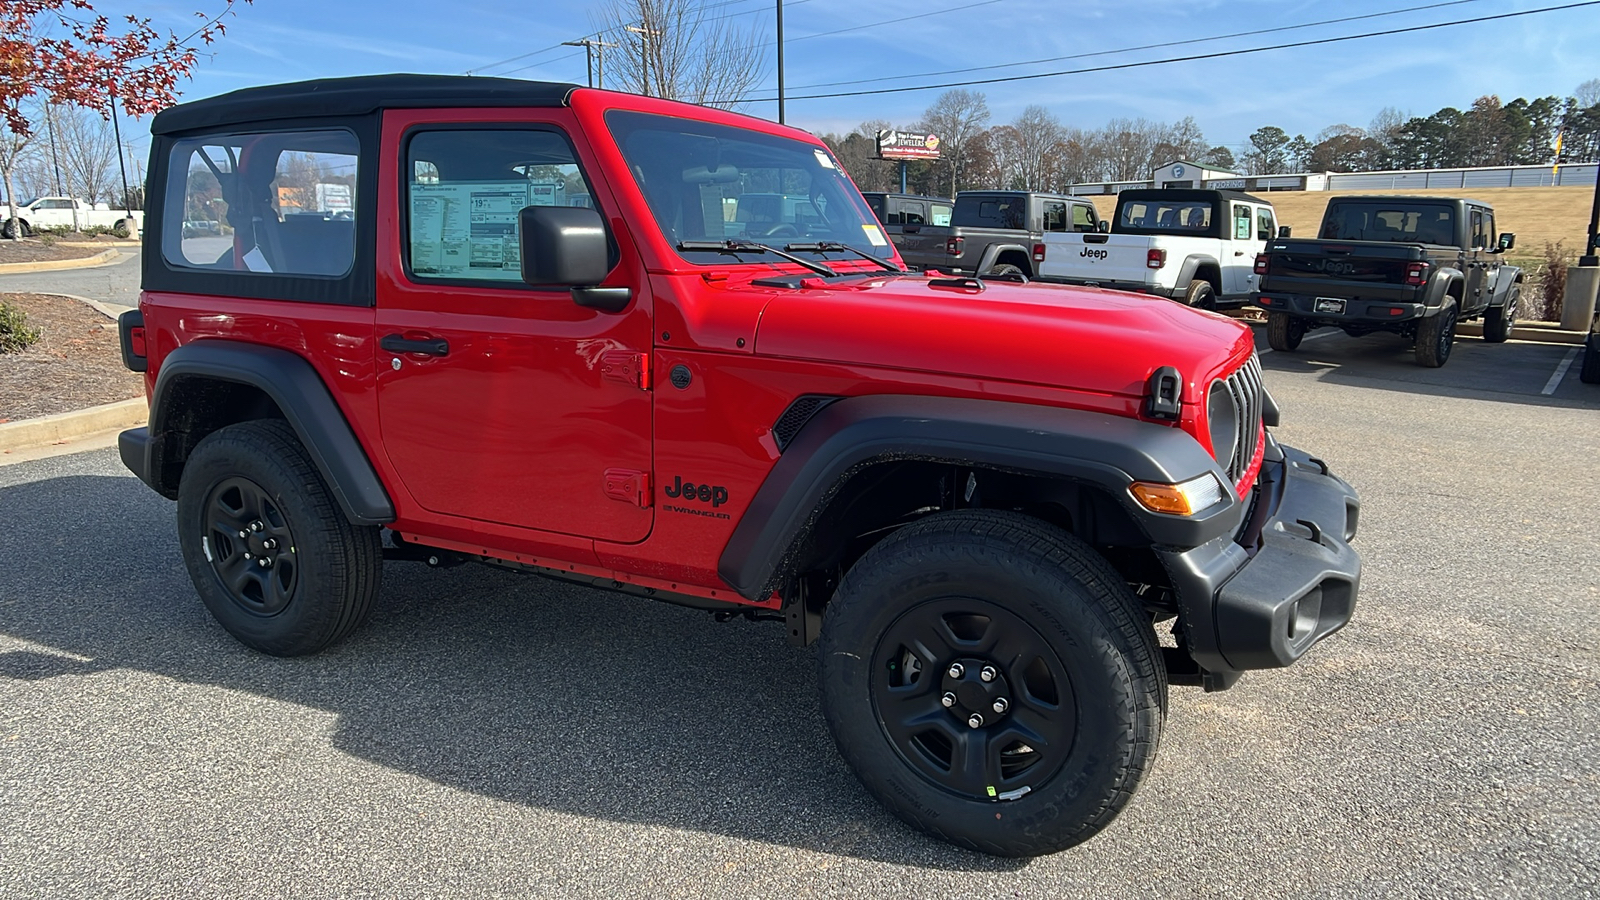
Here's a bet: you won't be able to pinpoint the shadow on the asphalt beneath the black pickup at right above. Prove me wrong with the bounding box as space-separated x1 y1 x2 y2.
1258 331 1600 410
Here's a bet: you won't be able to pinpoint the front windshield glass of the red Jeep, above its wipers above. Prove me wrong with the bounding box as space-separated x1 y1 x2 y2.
606 109 893 264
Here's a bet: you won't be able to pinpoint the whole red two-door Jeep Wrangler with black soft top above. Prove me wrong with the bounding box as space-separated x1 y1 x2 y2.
120 75 1360 855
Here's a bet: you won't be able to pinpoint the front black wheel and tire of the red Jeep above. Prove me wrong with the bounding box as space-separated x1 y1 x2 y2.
821 511 1166 857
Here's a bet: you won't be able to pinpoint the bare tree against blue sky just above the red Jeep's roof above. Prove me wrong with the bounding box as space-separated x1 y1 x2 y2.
598 0 766 109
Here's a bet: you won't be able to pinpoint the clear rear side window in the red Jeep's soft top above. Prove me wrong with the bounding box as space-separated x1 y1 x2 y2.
162 130 358 275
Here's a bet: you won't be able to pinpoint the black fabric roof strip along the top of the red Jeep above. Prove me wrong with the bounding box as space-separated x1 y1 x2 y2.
150 75 578 135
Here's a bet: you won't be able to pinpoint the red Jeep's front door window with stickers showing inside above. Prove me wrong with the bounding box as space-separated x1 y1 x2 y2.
405 128 594 283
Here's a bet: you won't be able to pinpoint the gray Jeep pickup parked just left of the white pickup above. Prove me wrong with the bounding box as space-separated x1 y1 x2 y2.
899 191 1101 279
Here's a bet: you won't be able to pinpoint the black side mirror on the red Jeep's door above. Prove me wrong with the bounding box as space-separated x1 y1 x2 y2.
517 207 634 312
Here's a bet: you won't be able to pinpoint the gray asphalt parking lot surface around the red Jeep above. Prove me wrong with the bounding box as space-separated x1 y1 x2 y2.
0 320 1600 898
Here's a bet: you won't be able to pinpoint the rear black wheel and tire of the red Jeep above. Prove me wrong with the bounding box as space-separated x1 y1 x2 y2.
178 420 382 657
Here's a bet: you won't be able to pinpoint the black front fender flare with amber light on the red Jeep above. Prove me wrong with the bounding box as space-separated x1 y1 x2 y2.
717 394 1243 601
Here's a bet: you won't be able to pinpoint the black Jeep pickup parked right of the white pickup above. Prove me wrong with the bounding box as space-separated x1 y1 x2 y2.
1254 197 1522 368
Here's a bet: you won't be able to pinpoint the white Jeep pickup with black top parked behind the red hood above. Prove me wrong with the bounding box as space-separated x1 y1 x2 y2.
1037 187 1278 307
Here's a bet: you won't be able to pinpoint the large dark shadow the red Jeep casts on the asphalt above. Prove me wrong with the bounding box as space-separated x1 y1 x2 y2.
0 476 1026 871
